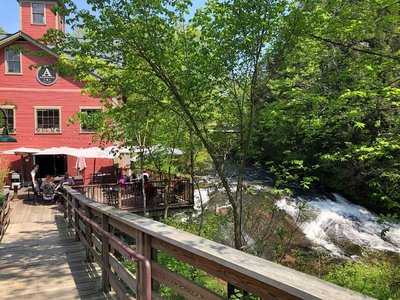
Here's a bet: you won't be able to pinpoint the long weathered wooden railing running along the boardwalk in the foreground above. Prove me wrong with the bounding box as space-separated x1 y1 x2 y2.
64 187 367 300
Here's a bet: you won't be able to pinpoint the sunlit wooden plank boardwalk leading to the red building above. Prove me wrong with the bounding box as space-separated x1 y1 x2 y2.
0 200 108 300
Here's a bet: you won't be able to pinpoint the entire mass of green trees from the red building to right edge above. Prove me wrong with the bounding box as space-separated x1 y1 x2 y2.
47 0 400 230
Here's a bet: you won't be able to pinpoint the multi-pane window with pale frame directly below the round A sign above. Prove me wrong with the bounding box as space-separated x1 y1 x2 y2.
36 108 61 133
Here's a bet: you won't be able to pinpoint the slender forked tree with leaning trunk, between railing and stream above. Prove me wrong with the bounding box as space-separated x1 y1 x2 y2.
52 0 286 248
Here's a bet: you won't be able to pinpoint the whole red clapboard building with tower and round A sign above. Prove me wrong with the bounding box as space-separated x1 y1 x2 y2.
0 0 112 183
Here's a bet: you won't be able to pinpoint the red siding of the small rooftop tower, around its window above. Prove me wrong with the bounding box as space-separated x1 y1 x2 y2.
20 1 64 39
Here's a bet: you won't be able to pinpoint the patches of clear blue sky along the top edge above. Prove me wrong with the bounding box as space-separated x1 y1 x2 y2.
0 0 206 33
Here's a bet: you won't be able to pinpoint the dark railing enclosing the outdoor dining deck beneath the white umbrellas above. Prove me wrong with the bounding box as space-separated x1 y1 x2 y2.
73 179 194 212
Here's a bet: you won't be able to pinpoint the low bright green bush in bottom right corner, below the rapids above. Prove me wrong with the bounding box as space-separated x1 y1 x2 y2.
325 261 400 300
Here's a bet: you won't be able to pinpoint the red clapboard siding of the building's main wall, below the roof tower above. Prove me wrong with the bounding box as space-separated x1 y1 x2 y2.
0 42 112 183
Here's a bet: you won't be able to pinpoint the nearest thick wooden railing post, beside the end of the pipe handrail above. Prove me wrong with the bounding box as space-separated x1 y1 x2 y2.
136 231 151 300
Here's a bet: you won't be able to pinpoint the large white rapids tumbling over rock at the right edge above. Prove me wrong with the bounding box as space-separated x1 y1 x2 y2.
276 194 400 256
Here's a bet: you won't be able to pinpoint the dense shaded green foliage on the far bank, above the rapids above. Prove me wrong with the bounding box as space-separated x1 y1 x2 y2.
253 0 400 213
